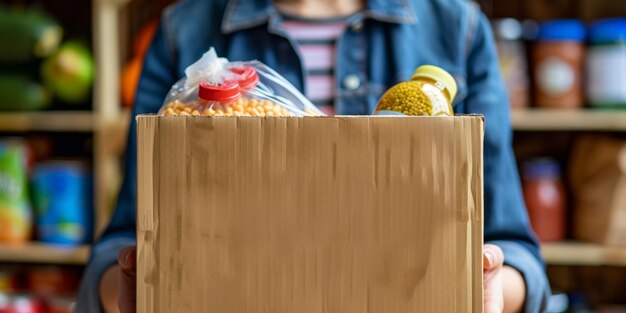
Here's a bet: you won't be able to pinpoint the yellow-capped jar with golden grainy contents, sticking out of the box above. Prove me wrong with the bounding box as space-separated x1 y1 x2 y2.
374 65 457 116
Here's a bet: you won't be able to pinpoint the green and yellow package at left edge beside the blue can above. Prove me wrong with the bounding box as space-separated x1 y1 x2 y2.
0 139 32 243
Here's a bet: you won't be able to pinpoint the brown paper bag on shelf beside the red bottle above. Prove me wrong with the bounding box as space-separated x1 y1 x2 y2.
568 134 626 246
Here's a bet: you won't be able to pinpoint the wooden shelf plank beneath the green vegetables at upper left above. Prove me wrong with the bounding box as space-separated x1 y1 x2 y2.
0 111 97 132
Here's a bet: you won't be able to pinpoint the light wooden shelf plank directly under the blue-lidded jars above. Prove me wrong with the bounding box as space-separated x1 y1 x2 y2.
511 109 626 131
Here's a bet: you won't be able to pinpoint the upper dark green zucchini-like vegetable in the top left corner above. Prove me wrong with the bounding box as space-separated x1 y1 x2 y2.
0 6 63 63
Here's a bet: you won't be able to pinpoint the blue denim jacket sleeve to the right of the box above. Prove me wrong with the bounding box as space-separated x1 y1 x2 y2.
465 9 550 313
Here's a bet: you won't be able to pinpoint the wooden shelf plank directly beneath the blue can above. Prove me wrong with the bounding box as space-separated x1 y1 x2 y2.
0 243 89 265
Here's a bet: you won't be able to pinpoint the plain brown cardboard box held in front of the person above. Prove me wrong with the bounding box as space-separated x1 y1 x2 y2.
137 116 483 313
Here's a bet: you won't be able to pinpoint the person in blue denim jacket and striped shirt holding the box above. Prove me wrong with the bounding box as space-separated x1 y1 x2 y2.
77 0 550 313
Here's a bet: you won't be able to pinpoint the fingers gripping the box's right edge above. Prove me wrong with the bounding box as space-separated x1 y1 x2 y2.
483 244 504 313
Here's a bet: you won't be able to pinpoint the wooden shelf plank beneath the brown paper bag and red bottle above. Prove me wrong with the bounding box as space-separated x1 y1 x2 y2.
541 242 626 266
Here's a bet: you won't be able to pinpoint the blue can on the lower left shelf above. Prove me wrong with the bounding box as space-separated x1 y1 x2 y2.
32 161 92 244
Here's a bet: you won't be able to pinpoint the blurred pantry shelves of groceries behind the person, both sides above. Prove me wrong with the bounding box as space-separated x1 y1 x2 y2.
0 0 626 313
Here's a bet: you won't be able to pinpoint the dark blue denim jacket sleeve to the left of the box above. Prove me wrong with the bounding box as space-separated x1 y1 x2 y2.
76 24 176 313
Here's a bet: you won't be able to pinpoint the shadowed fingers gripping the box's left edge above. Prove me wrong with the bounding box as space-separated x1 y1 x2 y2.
117 246 137 313
